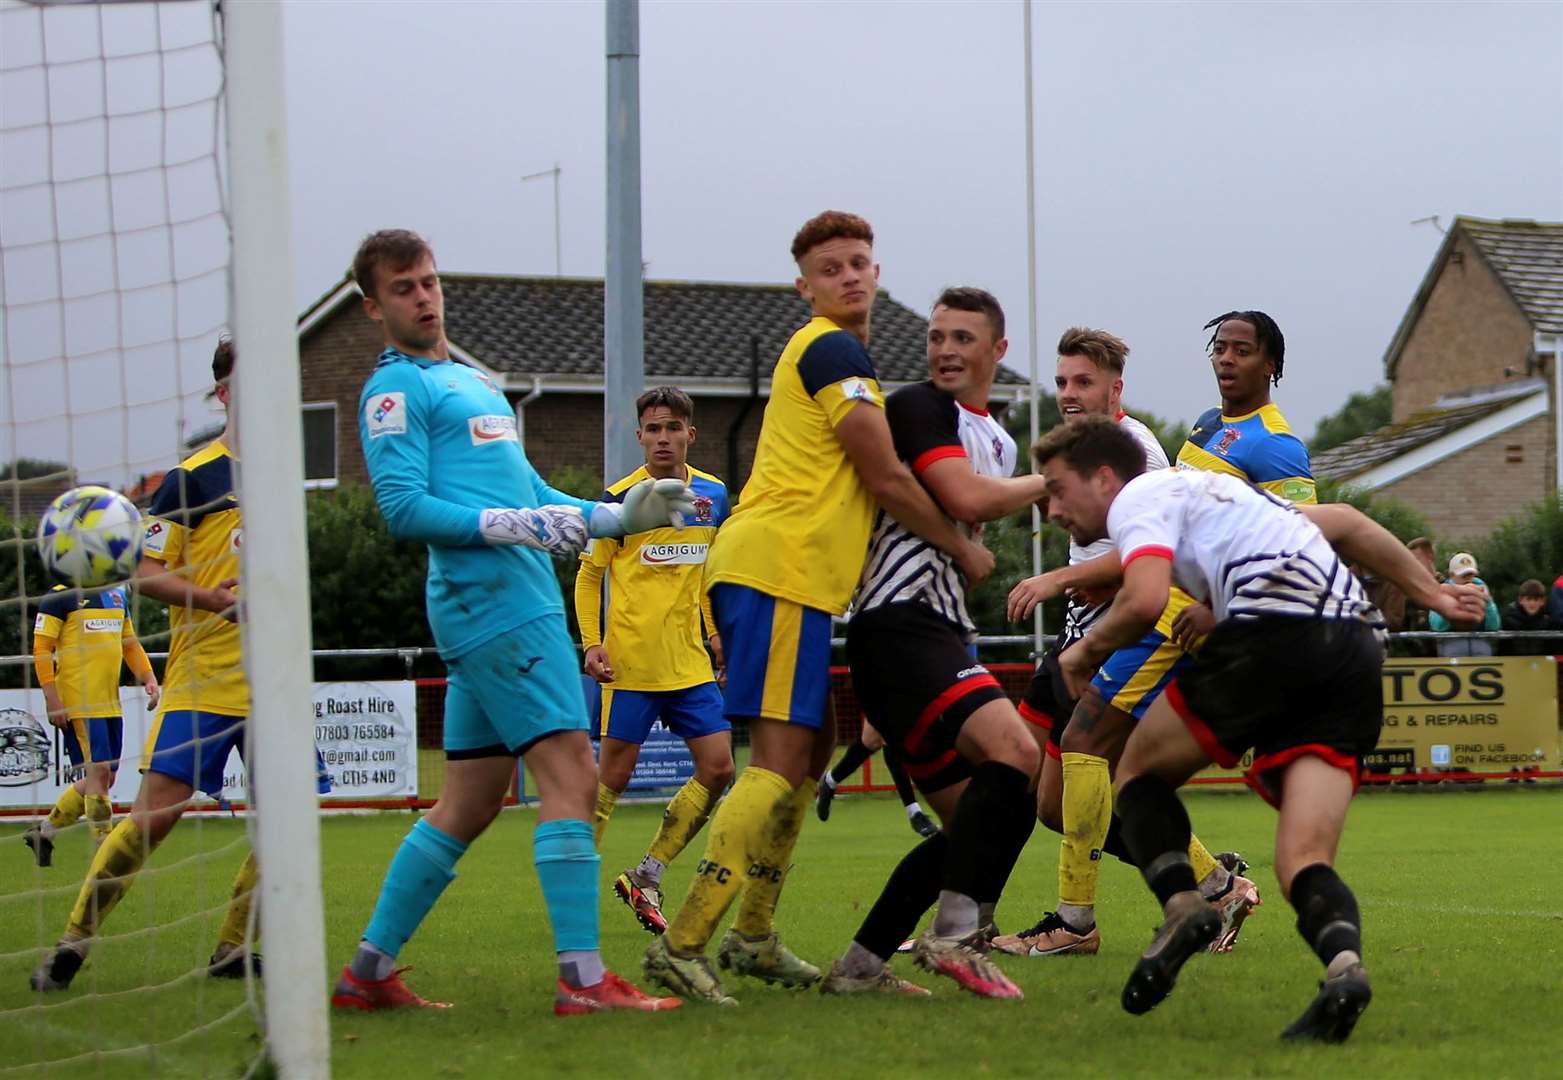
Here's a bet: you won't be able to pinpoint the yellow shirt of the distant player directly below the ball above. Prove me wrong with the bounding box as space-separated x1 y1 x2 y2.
33 585 145 721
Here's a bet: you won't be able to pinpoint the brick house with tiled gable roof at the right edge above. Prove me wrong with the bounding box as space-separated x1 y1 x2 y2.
1313 217 1563 541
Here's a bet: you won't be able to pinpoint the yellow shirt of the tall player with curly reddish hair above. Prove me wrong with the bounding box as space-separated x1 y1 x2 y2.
705 316 885 614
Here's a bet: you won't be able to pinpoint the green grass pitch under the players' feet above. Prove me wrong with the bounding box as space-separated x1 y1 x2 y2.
0 786 1563 1080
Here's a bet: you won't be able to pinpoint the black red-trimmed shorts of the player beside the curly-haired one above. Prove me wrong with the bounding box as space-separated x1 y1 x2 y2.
847 603 1007 791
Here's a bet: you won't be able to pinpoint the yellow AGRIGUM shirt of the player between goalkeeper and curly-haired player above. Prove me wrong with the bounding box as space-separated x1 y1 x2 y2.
575 466 727 691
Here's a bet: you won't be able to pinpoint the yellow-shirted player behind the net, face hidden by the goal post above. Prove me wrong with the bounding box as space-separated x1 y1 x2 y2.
31 339 275 991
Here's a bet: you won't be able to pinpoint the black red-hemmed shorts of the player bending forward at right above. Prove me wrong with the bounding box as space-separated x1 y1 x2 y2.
1166 617 1383 806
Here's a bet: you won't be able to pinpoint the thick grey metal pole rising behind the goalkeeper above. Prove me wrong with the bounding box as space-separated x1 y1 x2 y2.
602 0 646 483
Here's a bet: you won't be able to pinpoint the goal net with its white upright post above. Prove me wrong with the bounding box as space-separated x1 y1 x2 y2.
0 0 327 1075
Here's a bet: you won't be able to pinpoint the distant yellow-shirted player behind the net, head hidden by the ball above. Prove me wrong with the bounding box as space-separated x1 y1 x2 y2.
22 585 159 866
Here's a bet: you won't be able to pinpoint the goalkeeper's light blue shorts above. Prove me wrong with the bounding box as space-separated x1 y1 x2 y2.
445 614 591 758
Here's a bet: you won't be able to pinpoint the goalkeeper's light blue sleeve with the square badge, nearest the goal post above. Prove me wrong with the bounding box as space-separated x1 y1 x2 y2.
358 363 483 547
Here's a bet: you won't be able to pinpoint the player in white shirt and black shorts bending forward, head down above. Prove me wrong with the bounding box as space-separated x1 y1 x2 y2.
1033 417 1485 1042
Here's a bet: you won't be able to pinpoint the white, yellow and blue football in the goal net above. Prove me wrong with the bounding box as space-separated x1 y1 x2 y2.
38 485 145 589
